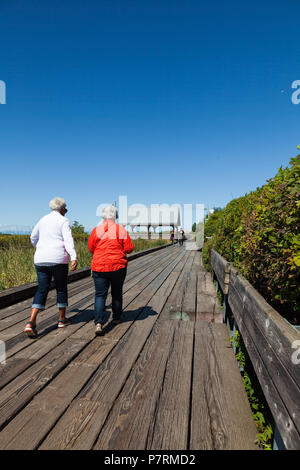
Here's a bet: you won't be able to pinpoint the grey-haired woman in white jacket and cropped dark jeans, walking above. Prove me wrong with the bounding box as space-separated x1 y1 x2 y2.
24 197 77 337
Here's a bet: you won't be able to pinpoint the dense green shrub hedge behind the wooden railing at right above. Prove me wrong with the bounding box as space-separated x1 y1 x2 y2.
203 155 300 324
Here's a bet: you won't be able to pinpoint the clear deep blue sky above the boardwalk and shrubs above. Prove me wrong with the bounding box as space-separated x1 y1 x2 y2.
0 0 300 229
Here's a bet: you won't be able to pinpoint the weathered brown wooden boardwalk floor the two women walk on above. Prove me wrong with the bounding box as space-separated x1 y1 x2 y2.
0 246 257 450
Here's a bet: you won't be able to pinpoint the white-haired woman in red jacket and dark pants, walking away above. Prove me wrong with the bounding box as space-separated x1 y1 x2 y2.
88 206 134 335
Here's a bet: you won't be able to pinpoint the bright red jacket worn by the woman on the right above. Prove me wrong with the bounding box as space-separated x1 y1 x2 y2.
88 220 134 272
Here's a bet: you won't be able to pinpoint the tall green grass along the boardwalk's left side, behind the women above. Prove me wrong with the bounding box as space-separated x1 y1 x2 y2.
0 236 168 290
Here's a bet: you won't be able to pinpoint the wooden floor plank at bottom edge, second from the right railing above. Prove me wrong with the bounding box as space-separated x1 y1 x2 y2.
145 322 194 450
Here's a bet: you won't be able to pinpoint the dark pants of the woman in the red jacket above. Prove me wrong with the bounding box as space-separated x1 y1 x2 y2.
92 268 127 324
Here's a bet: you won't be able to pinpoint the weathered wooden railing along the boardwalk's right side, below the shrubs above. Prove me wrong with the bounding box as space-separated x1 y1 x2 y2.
211 250 300 450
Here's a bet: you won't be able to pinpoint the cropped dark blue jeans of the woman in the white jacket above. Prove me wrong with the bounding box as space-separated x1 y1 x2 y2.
32 264 68 310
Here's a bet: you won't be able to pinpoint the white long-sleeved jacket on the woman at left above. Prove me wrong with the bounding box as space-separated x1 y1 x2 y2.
30 211 77 264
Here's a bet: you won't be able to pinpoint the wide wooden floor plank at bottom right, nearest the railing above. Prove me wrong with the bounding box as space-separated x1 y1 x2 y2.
190 323 257 450
